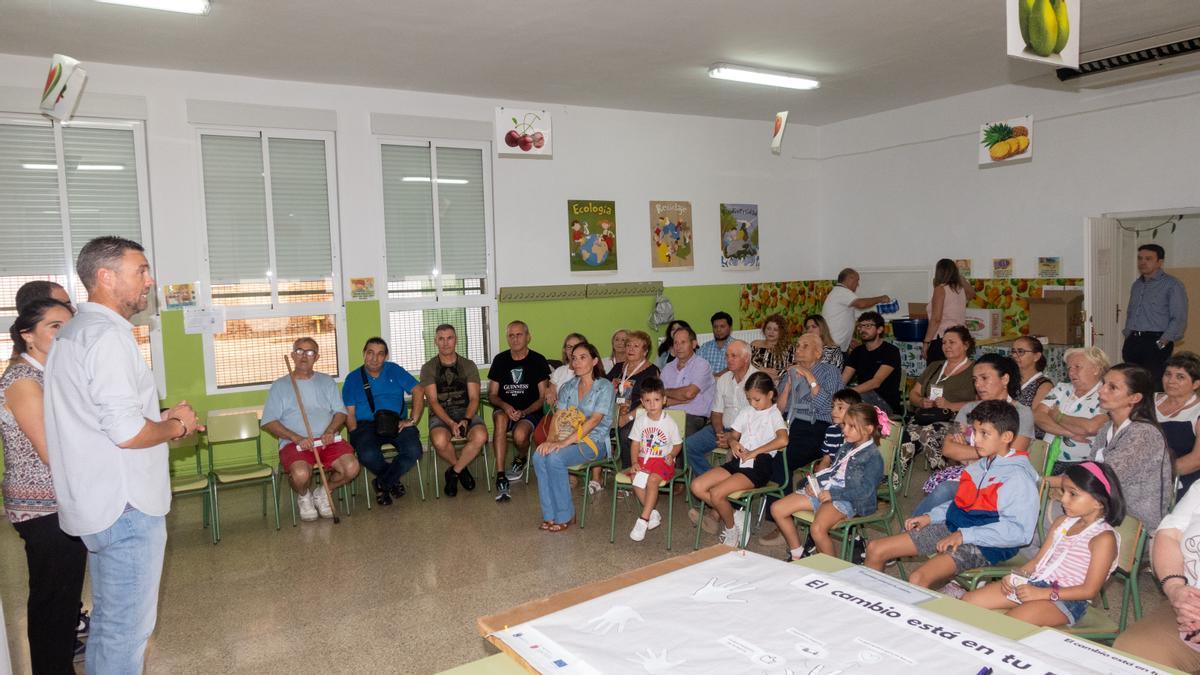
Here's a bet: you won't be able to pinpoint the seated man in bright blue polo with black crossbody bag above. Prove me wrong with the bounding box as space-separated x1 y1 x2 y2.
342 338 424 506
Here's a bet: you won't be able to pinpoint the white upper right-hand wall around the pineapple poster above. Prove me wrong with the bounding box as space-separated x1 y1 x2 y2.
818 69 1200 276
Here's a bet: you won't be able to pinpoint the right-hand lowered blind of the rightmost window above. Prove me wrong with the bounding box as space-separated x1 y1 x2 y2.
437 148 487 279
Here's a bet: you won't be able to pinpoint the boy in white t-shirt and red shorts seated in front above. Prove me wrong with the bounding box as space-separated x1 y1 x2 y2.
629 377 683 542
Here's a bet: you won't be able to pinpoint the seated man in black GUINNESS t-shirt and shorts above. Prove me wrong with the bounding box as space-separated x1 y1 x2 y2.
487 321 550 502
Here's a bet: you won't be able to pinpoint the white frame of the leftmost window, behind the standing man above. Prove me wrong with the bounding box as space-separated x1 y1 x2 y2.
0 112 167 400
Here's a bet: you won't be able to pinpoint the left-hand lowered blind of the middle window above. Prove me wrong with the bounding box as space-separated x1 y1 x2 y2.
200 135 270 283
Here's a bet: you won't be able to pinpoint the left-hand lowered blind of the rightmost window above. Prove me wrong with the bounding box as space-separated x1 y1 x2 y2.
383 145 440 281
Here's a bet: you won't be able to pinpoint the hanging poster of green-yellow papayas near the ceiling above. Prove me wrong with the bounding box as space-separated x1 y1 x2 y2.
1007 0 1080 70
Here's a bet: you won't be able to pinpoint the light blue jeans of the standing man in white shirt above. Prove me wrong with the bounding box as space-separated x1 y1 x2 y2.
80 509 167 675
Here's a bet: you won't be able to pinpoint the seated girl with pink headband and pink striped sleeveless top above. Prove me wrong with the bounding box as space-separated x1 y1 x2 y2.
962 461 1124 626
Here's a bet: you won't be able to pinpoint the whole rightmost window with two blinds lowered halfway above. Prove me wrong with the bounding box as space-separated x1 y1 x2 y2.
380 141 497 370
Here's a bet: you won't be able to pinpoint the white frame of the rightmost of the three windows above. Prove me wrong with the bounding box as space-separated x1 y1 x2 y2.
374 135 499 369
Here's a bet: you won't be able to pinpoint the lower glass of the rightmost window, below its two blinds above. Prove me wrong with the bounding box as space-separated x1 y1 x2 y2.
388 307 492 374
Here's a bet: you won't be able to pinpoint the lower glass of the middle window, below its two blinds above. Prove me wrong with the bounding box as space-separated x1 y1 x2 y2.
212 315 338 388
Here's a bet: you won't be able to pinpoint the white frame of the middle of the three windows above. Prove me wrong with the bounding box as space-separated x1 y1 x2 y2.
193 125 349 396
